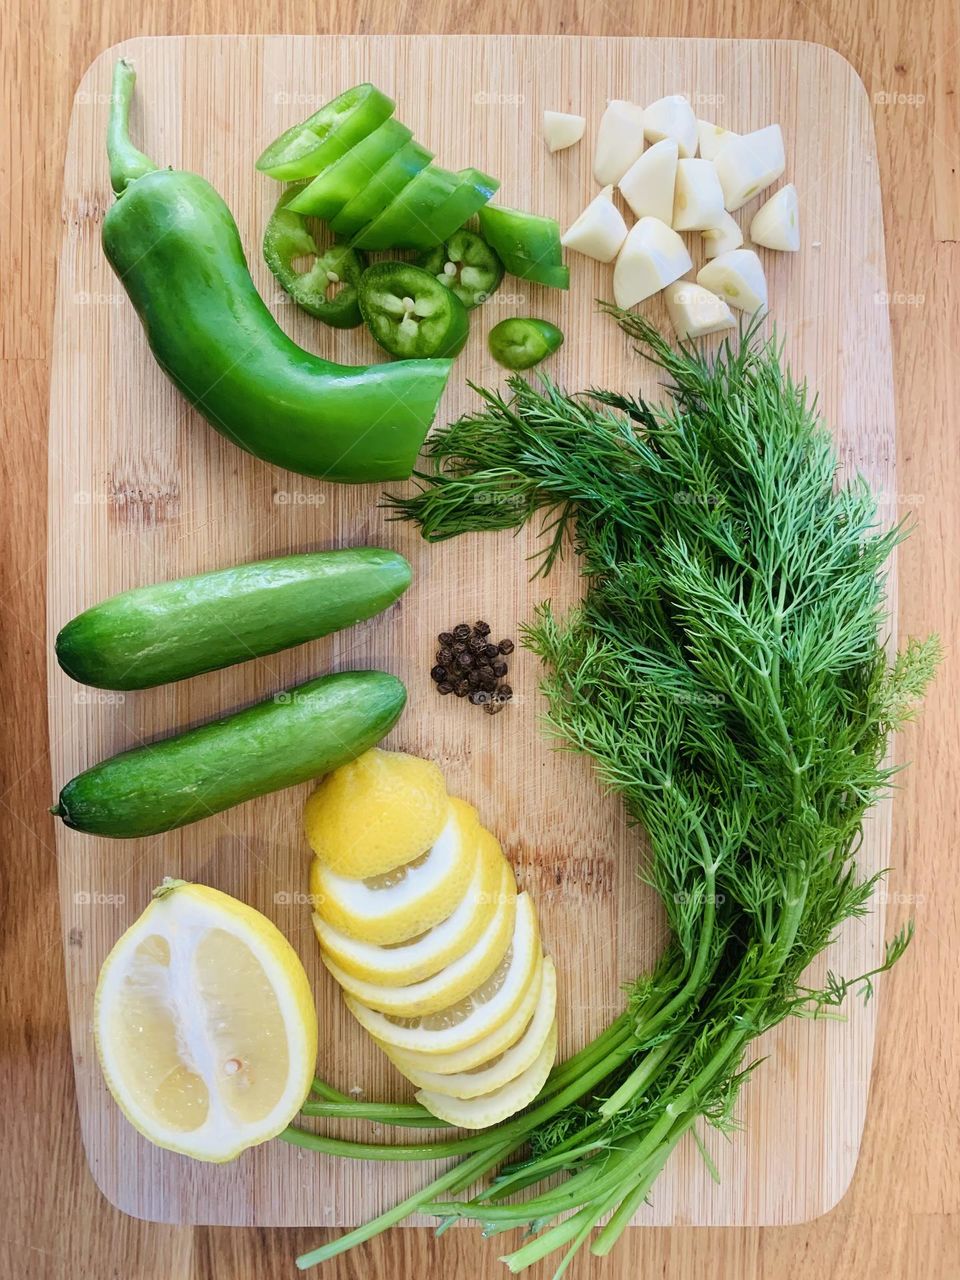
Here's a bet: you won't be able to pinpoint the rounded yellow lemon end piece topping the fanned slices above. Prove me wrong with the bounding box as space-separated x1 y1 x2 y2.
303 748 447 878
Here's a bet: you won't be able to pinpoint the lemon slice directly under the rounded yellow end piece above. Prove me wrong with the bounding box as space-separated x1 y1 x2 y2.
310 800 480 946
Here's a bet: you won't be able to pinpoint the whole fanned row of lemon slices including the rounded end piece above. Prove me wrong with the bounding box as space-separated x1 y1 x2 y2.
303 749 557 1129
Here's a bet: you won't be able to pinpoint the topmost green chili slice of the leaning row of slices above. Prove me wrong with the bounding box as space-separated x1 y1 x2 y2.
257 84 394 182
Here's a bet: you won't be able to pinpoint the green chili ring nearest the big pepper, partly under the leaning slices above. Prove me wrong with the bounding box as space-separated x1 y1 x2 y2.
264 187 366 329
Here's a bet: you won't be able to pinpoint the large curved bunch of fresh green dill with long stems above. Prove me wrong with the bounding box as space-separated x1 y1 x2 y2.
371 314 940 1270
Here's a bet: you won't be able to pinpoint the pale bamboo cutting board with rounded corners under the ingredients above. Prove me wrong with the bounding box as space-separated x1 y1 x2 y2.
49 36 895 1225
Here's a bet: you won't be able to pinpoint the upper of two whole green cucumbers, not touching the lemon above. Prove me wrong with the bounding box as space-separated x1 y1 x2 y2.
56 547 411 689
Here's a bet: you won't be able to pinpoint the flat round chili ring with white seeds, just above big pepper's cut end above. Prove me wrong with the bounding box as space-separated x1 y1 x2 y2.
358 262 470 360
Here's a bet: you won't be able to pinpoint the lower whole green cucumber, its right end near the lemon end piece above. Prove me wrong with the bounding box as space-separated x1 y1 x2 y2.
51 671 407 840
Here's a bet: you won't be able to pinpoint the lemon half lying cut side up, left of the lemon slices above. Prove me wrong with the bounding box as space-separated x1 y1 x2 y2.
93 881 317 1162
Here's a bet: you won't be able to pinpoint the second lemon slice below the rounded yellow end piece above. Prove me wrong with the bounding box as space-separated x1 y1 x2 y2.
314 831 517 987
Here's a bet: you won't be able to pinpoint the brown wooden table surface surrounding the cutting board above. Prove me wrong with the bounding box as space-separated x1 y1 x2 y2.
0 0 960 1280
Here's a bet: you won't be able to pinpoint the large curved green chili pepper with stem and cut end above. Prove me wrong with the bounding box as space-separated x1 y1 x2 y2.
102 60 451 483
